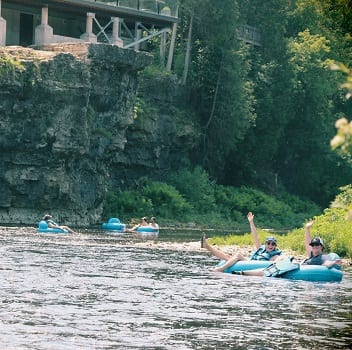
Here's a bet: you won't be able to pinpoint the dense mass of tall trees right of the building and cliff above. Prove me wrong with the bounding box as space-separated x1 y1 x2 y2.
135 0 352 211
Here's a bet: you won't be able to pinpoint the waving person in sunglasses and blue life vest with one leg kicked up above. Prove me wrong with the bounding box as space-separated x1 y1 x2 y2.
201 212 282 272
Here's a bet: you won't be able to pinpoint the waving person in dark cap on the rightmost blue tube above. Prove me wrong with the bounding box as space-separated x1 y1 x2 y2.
302 220 342 267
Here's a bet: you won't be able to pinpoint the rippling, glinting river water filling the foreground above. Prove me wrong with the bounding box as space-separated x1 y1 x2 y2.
0 228 352 350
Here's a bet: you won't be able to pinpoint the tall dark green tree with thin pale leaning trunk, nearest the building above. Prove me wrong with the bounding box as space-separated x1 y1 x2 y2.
182 0 251 179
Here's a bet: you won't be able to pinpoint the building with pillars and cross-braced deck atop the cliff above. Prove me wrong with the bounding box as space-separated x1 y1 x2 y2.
0 0 179 49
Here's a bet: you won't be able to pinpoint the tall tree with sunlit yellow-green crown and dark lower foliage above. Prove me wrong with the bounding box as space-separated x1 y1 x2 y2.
277 30 350 205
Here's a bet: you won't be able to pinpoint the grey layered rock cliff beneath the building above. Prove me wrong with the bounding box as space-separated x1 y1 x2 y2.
0 44 198 226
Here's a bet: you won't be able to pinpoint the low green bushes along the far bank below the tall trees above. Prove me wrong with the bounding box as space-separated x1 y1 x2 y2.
104 167 326 231
